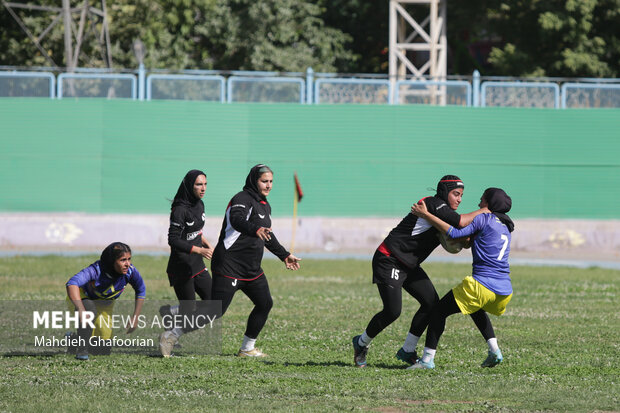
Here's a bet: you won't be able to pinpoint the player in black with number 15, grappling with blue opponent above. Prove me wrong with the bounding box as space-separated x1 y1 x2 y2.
353 175 483 367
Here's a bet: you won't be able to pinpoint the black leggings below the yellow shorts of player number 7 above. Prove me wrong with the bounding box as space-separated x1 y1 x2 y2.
425 290 495 349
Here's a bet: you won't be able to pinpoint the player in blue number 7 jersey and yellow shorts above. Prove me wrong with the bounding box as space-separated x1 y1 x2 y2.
409 188 514 369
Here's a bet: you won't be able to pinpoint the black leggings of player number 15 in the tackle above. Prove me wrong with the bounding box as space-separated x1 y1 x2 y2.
366 267 439 338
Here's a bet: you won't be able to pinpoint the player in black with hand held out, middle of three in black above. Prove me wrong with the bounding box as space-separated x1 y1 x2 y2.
211 164 300 357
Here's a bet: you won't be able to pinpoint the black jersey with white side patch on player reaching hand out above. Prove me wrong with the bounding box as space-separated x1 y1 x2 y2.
211 191 290 280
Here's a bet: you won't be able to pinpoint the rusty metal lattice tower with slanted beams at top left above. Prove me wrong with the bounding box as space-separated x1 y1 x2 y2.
2 0 112 72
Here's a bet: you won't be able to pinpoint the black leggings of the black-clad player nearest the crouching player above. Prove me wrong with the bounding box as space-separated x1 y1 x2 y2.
173 269 212 333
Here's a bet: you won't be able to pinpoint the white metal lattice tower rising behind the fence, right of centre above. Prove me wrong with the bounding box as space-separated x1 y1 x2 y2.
389 0 448 82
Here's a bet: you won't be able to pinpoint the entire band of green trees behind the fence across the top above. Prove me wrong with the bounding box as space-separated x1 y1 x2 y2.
0 0 620 77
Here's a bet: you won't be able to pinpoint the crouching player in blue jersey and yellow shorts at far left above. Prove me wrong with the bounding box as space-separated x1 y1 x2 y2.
66 242 146 360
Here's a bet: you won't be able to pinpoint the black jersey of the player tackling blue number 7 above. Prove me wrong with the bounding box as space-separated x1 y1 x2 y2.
378 196 461 269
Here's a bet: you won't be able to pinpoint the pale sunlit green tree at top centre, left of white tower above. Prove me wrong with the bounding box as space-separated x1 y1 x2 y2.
204 0 352 72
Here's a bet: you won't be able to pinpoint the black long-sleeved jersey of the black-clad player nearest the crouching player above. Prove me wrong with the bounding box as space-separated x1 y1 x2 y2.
166 201 206 282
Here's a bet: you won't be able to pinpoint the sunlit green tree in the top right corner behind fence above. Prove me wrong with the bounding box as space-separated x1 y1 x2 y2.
482 0 620 77
